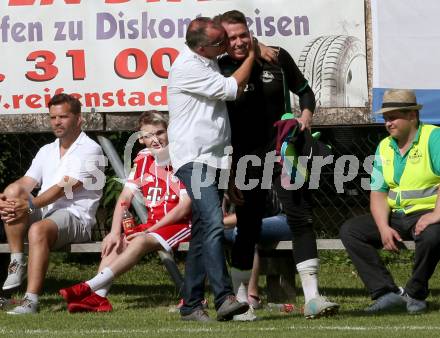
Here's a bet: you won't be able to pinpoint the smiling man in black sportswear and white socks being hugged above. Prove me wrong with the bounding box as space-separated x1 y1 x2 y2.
216 11 339 320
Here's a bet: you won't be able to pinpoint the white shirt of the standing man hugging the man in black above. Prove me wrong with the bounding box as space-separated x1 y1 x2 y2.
168 46 237 171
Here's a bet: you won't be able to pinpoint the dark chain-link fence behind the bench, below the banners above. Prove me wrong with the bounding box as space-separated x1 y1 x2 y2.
0 125 386 240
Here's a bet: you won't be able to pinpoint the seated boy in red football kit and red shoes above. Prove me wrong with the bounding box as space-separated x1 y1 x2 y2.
60 111 191 312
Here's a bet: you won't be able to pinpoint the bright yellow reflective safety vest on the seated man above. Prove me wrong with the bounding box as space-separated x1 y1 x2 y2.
379 125 440 213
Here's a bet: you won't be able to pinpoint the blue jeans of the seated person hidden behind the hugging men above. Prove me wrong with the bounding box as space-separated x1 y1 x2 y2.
225 215 292 244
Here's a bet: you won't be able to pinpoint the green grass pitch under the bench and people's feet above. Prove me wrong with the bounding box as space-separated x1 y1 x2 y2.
0 252 440 338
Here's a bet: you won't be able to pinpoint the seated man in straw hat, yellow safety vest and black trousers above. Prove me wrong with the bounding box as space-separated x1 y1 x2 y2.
340 89 440 314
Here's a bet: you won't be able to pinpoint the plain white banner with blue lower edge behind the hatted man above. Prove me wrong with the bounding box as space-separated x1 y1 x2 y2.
371 0 440 124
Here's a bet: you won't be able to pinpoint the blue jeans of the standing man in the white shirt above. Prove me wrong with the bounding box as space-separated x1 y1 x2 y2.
176 162 234 315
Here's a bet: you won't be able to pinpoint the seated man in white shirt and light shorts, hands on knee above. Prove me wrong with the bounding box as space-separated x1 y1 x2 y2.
0 94 105 314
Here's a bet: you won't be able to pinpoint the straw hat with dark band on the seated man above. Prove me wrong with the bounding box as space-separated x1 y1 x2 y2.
374 89 423 114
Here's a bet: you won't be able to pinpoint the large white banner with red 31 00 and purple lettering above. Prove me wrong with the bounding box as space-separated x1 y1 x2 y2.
0 0 368 114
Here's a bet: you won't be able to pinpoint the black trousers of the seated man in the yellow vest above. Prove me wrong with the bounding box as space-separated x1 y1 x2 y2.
340 211 440 300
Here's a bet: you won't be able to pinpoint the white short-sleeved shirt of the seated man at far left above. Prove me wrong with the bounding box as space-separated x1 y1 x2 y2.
25 132 105 232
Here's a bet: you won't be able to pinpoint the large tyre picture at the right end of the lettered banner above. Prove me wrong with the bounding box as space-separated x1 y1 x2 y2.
295 35 368 107
